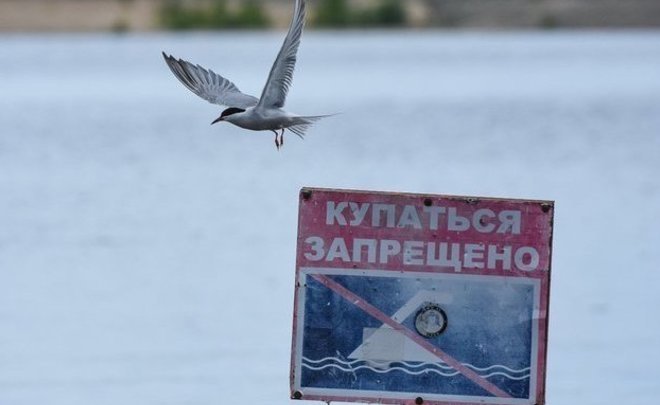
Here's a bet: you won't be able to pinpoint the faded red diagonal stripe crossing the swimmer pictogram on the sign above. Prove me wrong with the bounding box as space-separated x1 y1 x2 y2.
310 274 511 398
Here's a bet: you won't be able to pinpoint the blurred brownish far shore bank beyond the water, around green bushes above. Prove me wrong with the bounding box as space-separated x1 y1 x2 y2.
0 0 660 32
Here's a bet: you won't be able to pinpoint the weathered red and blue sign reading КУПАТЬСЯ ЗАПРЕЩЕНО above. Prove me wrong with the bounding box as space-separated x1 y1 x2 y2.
291 188 554 405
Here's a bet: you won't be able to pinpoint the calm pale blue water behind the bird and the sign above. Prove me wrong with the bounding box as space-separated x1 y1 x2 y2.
0 31 660 405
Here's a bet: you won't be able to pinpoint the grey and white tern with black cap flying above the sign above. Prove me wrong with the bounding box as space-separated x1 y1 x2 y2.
163 0 328 150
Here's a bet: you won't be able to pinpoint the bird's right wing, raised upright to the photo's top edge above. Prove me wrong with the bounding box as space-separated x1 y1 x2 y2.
259 0 305 108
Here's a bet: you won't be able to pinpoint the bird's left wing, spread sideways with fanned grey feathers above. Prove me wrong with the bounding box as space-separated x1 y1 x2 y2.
163 52 259 109
